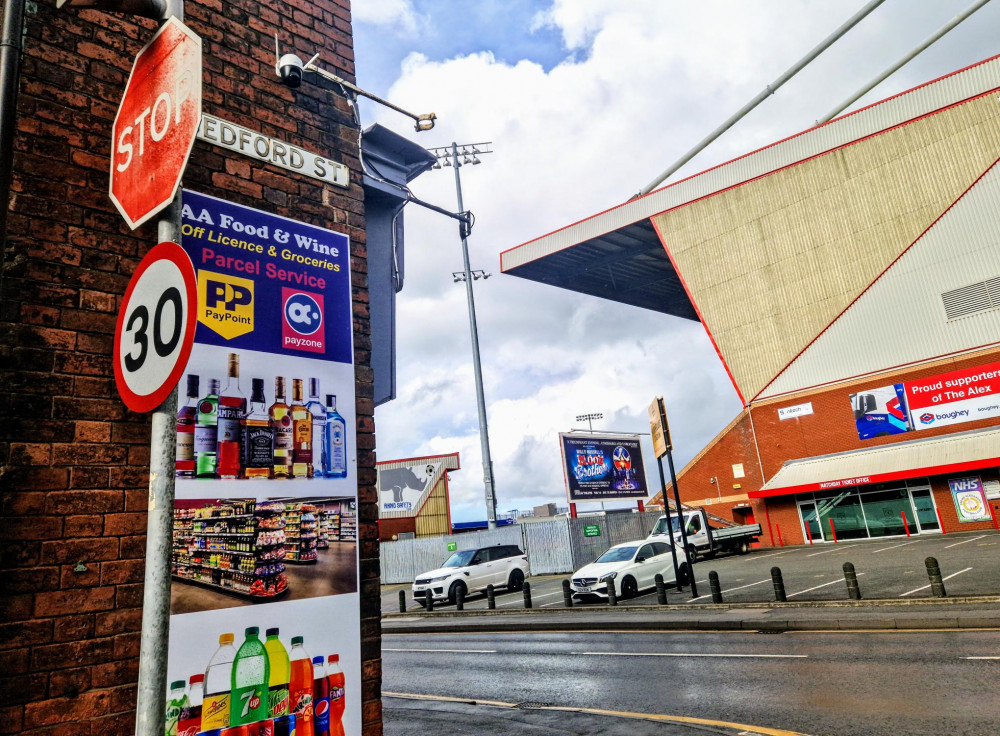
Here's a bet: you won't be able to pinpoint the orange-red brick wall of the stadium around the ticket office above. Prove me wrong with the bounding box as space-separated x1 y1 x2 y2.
657 349 1000 545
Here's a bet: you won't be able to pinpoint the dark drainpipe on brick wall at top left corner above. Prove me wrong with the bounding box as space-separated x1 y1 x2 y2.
0 0 24 295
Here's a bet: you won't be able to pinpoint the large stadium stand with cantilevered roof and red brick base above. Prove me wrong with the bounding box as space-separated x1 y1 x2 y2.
501 57 1000 544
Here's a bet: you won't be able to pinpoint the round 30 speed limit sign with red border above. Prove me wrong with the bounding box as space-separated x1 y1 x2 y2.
114 243 198 411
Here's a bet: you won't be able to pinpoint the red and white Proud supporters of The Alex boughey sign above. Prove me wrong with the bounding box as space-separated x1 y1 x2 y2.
904 363 1000 429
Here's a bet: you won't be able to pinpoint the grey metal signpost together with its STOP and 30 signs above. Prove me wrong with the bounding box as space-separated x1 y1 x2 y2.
109 8 202 736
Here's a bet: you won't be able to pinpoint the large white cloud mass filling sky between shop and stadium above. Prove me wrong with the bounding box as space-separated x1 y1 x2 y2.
366 0 1000 518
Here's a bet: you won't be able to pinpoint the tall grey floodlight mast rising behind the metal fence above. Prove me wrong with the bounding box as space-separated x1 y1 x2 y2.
427 142 497 529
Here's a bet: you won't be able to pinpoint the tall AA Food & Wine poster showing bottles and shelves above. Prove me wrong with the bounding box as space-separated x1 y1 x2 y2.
167 191 361 736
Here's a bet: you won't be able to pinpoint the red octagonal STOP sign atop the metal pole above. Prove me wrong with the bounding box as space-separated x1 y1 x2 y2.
110 18 201 230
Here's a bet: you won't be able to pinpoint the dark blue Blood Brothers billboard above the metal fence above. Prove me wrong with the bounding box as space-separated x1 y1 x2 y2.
559 433 649 503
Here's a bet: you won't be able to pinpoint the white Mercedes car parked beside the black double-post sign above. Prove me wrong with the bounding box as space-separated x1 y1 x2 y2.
570 540 690 600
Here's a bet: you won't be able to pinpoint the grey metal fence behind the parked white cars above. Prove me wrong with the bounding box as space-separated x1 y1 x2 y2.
380 512 660 583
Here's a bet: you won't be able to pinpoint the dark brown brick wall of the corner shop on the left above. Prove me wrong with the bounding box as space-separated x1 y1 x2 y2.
0 0 381 736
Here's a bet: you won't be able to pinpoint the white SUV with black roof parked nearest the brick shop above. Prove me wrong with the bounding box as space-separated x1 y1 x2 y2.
412 544 528 603
